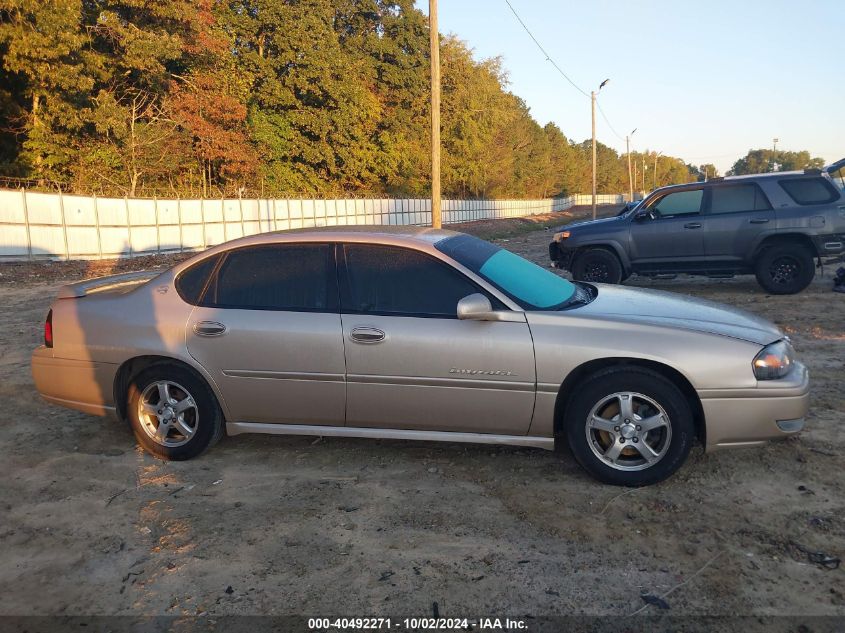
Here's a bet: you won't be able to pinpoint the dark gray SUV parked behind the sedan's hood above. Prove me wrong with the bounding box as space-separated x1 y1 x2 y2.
549 159 845 294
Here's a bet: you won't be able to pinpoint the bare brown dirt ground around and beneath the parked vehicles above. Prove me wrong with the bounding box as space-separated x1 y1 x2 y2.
0 205 845 616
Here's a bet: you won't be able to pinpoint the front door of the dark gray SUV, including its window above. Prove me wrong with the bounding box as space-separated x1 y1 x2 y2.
630 187 704 271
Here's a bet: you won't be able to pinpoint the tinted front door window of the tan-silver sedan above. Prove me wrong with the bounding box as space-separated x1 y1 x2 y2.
341 244 480 318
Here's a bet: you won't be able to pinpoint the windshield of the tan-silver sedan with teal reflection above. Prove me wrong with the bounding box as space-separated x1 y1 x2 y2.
435 235 577 310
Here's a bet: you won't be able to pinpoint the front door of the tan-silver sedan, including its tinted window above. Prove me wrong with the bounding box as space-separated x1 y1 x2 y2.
339 244 535 435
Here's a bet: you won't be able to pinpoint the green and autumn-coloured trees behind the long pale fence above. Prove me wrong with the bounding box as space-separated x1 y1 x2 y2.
0 0 716 197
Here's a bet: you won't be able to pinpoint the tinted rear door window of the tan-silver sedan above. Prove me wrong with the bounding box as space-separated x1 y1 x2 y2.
202 244 336 312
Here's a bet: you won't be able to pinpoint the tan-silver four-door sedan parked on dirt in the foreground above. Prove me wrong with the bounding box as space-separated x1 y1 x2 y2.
32 227 809 486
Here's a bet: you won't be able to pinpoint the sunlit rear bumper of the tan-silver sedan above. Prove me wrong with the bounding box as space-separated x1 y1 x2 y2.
32 345 118 416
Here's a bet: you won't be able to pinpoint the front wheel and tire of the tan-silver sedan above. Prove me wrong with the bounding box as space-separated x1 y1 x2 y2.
564 367 695 486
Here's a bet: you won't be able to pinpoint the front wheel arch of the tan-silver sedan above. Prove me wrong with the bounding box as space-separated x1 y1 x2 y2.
554 357 707 446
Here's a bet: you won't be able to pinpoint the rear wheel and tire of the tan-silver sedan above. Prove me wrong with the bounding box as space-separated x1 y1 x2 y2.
126 363 223 461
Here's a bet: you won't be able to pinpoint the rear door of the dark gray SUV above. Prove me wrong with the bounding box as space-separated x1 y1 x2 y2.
704 182 775 262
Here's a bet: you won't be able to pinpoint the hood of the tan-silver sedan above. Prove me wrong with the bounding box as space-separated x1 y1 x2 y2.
570 284 784 345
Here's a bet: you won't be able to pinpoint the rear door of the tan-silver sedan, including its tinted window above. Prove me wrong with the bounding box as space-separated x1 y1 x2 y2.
187 243 346 426
